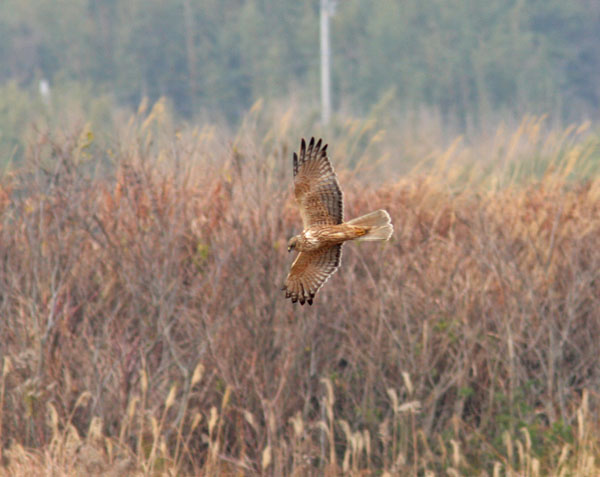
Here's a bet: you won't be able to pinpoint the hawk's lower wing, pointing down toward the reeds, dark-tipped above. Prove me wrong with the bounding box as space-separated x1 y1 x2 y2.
283 243 342 305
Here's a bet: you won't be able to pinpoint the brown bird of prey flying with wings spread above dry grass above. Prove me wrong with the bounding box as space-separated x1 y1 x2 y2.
282 137 394 305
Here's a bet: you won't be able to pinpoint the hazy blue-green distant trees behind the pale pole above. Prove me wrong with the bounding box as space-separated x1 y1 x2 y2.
0 0 600 122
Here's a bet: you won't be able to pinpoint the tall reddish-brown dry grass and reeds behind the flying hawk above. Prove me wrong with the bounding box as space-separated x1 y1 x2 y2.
0 99 600 477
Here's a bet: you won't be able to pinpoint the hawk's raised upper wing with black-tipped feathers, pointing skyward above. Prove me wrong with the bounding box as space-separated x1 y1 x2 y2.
294 137 344 229
